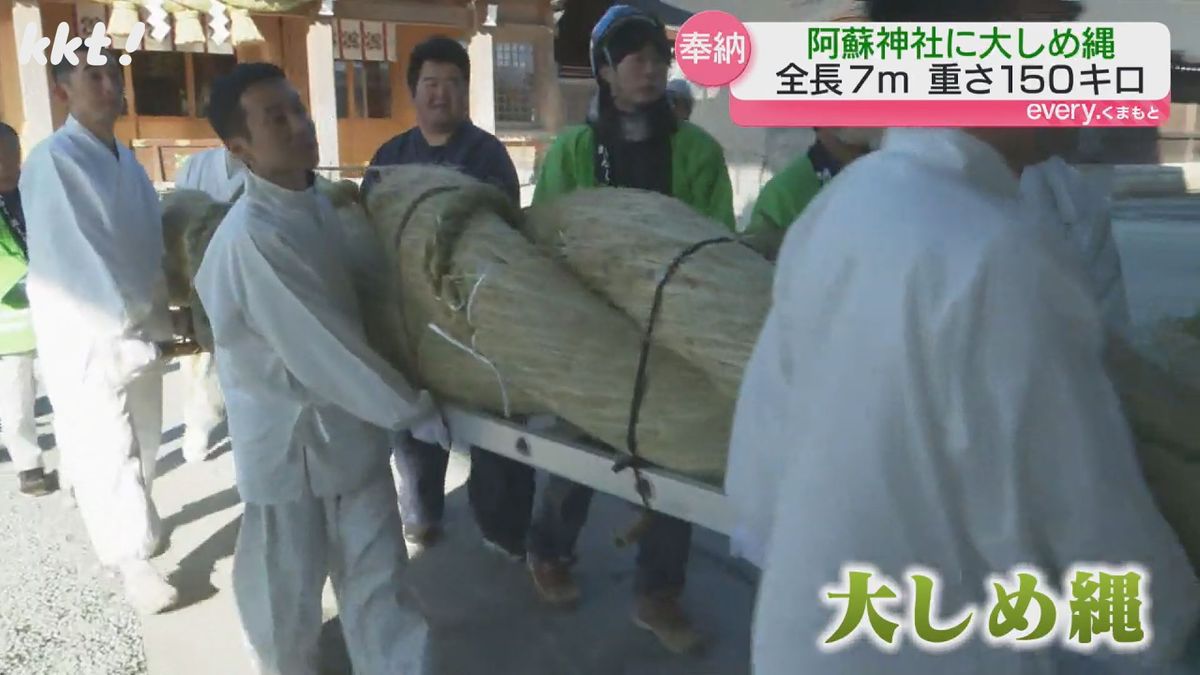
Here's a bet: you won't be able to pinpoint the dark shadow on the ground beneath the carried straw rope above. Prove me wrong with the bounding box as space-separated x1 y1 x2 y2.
304 473 755 675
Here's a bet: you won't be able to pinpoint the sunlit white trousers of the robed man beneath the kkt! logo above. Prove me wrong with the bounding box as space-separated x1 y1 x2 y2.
47 369 162 567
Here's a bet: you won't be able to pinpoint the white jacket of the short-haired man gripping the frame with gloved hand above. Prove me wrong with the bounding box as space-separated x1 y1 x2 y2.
196 173 432 503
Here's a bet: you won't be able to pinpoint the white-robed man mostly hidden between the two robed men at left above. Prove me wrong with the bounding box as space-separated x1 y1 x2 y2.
175 148 246 462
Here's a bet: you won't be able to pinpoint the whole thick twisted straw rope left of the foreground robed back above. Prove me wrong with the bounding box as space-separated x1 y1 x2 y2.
163 166 773 484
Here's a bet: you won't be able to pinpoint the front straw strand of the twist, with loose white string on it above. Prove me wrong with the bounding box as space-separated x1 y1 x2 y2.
367 166 734 482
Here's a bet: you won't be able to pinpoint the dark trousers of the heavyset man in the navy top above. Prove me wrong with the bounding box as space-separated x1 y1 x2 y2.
392 429 534 552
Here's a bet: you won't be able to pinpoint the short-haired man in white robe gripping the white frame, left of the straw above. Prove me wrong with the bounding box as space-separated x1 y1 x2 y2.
196 64 439 675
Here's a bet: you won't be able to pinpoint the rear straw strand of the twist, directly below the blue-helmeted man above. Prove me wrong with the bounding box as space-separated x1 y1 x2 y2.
523 189 774 399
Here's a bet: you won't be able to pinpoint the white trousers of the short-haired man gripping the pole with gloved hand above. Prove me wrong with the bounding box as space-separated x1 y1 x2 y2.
233 466 430 675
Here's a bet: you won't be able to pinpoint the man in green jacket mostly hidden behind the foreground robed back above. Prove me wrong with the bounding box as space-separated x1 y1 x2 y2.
744 129 882 261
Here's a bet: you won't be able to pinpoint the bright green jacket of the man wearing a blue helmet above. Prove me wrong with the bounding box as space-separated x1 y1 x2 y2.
533 121 736 229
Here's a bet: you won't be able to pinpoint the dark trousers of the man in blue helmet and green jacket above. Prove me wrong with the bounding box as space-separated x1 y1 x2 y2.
527 476 691 595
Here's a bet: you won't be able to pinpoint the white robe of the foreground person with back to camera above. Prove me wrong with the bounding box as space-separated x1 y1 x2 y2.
726 130 1200 675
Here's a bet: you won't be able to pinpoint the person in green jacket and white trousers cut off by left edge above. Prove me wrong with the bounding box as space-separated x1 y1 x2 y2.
0 123 54 496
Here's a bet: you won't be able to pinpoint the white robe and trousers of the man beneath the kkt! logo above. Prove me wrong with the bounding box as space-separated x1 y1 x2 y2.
20 118 172 565
